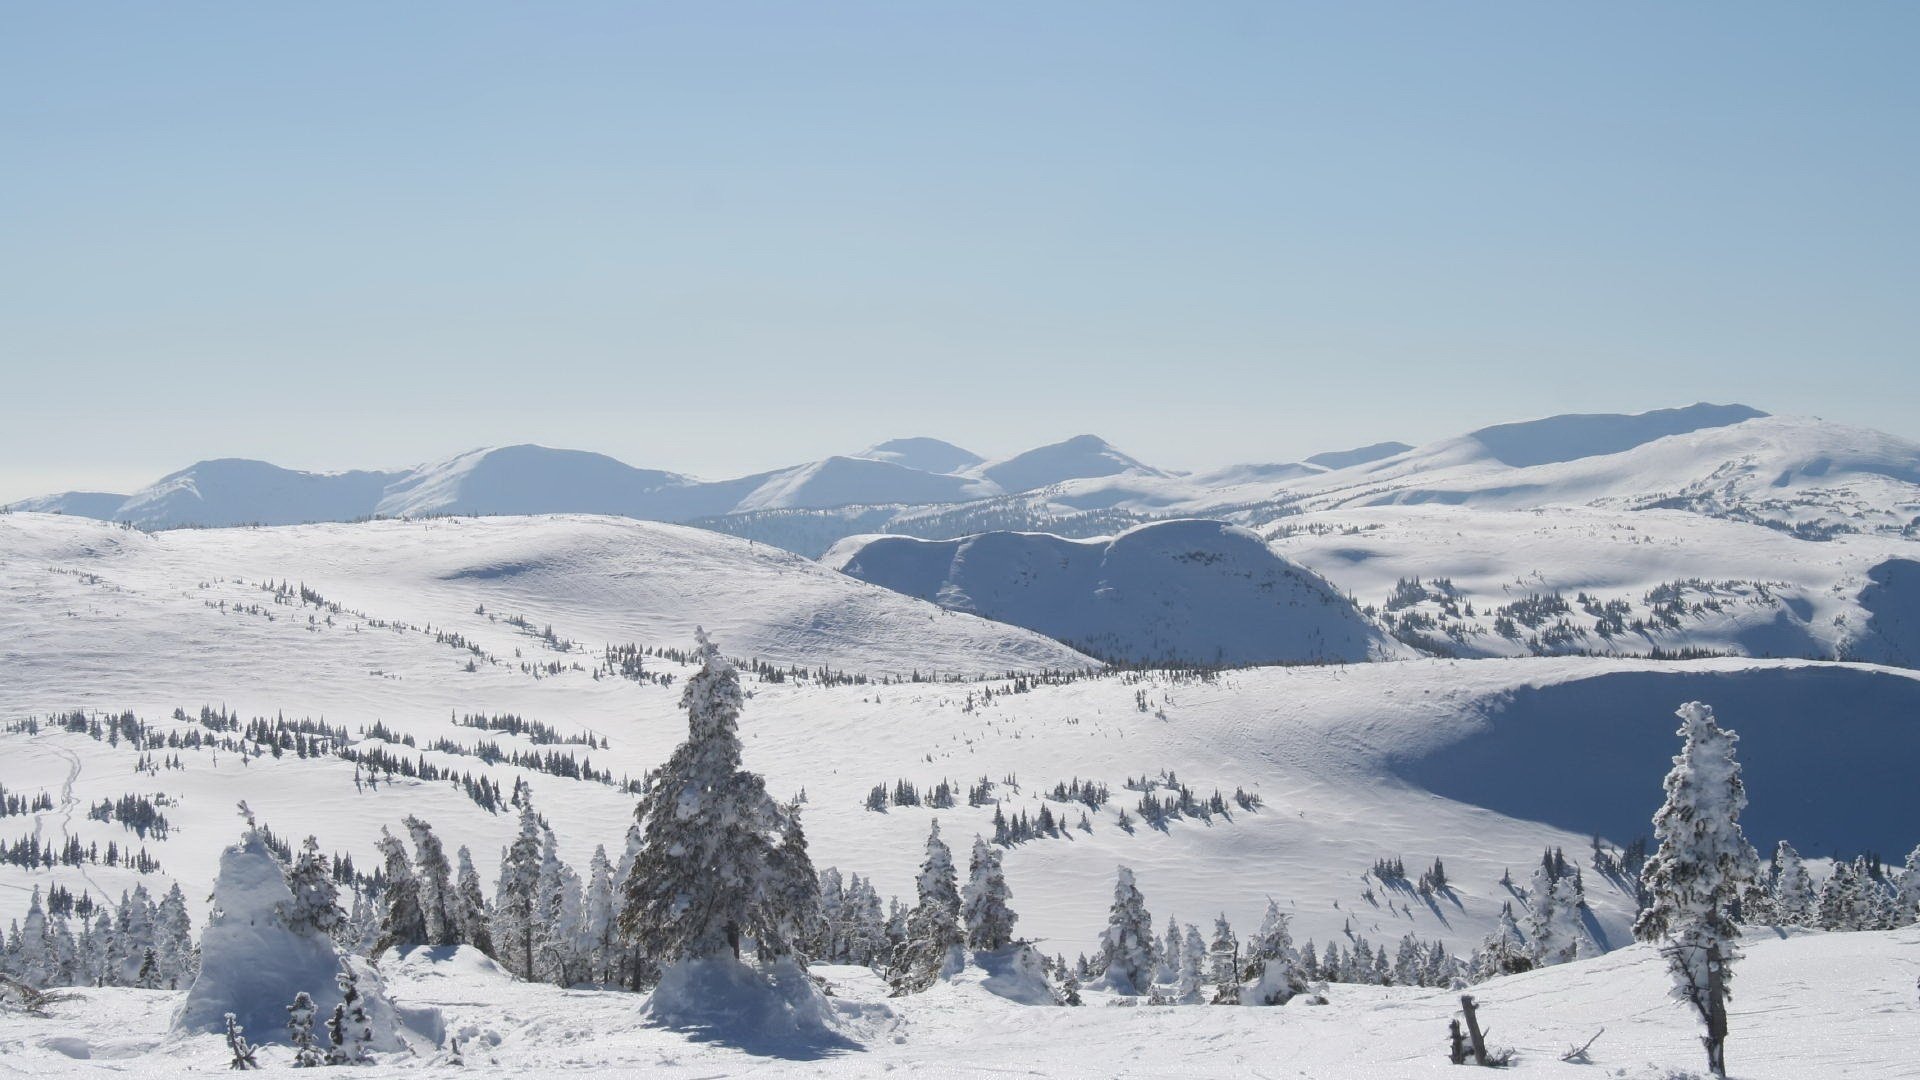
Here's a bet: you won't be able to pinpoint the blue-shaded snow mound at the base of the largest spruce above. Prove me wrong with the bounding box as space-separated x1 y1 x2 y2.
641 957 891 1057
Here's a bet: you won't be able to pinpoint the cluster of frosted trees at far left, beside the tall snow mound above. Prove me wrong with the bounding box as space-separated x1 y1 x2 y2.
0 886 200 990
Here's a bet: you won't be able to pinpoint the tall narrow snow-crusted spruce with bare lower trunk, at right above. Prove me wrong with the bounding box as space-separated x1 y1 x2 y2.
1634 701 1759 1076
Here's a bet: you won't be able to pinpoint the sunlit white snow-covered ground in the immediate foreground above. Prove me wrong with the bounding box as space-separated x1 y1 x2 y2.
0 928 1920 1080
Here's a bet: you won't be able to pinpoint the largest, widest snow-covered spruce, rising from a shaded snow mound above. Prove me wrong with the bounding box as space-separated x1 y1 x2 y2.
620 632 810 969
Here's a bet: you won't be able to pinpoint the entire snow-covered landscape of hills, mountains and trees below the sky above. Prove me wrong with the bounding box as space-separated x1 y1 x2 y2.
0 405 1920 1080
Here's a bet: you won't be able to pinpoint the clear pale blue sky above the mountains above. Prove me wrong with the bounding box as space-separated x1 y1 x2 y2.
0 0 1920 500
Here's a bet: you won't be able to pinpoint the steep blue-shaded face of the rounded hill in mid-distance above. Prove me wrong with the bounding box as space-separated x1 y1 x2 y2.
824 521 1407 665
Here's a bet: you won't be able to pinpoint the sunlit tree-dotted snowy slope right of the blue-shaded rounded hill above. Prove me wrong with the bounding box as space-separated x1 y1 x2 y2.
1265 505 1920 665
